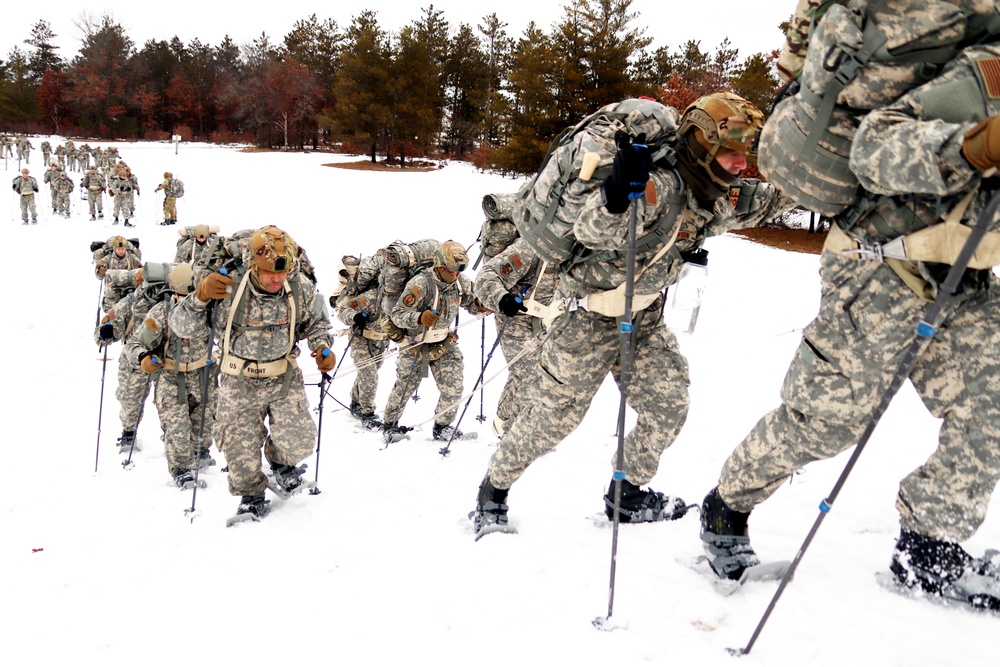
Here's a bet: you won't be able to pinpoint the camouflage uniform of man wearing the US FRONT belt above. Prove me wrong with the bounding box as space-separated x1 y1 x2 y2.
169 264 332 496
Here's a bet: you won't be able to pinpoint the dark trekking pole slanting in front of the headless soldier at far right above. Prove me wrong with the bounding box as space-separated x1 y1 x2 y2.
726 185 1000 656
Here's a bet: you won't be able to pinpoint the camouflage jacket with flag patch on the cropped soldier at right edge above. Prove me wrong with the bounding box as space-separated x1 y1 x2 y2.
851 45 1000 241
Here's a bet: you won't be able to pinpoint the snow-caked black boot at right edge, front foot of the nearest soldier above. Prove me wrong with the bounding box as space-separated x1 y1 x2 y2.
889 528 1000 611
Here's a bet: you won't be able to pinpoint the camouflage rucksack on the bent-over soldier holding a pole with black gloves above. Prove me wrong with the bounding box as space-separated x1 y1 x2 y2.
514 99 686 271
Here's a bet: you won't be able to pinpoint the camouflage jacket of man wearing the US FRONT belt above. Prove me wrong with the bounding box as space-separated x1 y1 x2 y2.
169 274 333 362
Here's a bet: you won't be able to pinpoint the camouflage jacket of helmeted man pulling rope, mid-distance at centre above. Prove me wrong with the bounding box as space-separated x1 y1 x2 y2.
389 268 488 339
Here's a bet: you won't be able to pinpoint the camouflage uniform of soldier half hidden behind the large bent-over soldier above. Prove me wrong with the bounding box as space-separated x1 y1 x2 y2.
476 239 555 426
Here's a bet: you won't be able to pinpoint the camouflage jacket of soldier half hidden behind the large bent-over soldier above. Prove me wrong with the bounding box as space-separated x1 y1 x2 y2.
475 239 556 311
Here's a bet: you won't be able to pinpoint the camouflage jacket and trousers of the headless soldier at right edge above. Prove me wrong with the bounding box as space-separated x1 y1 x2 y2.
719 41 1000 541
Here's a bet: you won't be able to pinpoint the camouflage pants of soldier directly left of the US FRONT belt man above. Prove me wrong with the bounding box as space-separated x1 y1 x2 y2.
154 366 218 475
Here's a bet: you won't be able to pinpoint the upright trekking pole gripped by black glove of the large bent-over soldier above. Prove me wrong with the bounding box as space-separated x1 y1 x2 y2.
592 142 642 630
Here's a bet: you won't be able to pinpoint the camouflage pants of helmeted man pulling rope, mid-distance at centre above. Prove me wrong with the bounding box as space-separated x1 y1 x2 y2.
382 342 464 424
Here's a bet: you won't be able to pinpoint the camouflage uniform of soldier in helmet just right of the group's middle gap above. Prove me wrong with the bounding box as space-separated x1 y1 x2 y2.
382 268 484 426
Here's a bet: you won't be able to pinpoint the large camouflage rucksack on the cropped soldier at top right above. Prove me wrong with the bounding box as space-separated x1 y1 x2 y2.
757 0 1000 217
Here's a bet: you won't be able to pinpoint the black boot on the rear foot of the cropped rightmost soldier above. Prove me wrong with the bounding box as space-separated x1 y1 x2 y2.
701 487 760 581
